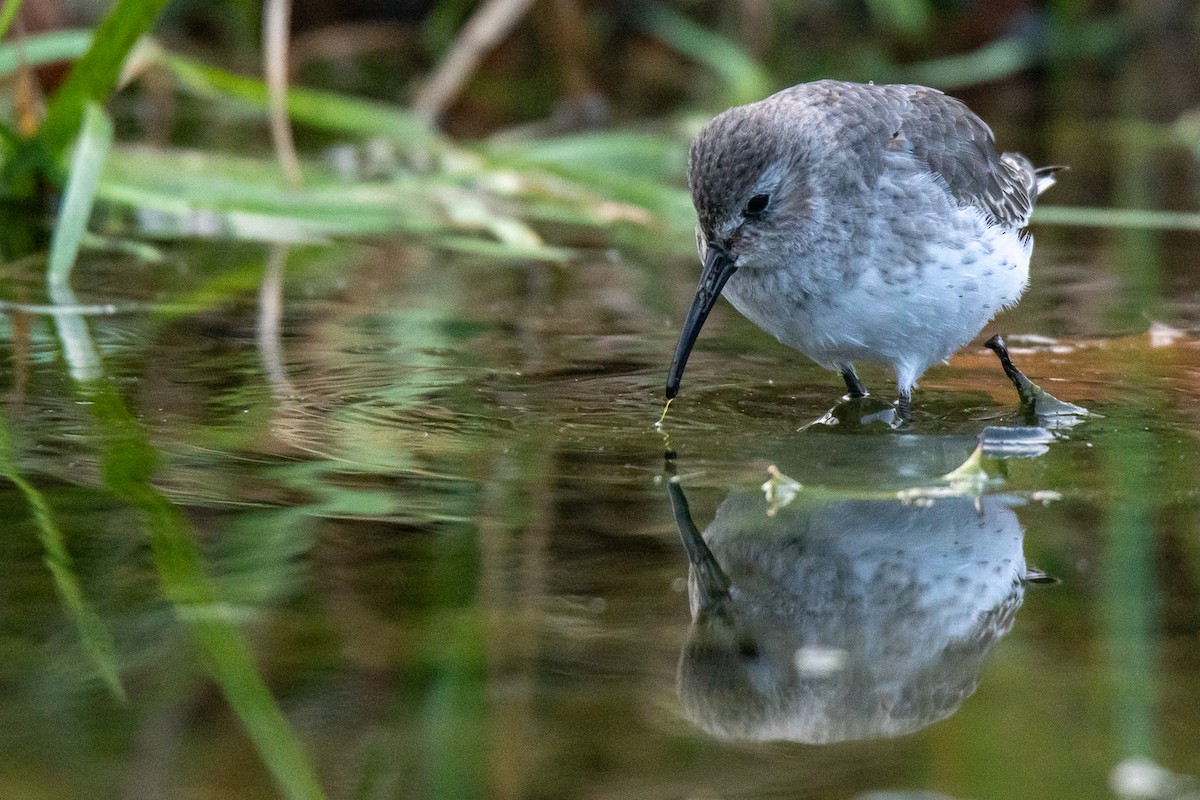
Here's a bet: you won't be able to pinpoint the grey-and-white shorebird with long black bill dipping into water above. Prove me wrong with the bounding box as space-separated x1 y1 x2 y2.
666 80 1062 425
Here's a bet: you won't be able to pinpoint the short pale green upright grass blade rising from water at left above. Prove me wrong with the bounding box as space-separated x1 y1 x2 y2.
46 103 113 287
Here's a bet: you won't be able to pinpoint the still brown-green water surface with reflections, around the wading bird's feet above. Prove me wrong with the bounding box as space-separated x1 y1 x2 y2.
0 160 1200 800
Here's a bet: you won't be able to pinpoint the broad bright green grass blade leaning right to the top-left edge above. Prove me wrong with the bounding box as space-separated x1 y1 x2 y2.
37 0 167 160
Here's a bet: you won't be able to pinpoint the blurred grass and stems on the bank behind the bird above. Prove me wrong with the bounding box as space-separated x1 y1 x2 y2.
0 0 1200 275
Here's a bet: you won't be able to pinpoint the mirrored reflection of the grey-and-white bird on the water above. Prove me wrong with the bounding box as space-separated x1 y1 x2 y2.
668 479 1045 744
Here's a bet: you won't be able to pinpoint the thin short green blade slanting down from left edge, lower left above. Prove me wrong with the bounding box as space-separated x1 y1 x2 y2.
0 416 125 702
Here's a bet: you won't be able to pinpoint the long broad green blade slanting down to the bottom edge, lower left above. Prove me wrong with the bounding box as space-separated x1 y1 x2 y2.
86 385 325 800
